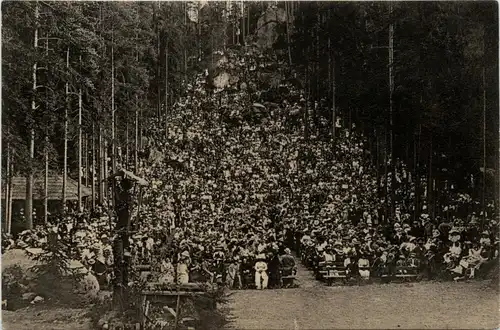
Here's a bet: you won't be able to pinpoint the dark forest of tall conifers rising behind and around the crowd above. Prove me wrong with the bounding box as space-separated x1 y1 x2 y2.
2 1 499 228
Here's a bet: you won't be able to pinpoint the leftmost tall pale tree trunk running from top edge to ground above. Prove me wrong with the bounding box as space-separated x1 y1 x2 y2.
24 1 39 229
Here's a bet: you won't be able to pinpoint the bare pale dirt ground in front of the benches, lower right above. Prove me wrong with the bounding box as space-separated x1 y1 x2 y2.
229 262 500 330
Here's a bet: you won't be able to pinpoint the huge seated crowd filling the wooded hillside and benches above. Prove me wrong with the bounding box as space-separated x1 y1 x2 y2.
2 45 499 288
